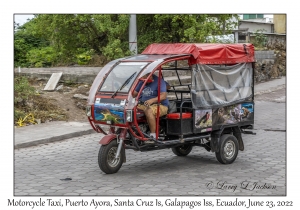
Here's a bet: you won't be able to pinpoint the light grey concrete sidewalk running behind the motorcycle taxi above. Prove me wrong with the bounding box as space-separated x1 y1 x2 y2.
14 77 286 149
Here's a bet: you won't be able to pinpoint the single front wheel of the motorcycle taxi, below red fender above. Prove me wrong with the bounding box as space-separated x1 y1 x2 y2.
98 139 125 174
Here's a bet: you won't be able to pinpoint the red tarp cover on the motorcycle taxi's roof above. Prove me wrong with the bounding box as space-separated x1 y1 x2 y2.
142 43 255 64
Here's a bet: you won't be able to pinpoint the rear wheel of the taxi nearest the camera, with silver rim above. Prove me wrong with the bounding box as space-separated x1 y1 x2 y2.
216 134 239 164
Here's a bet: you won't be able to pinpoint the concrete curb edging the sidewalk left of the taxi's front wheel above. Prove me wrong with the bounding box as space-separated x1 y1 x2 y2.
14 129 95 149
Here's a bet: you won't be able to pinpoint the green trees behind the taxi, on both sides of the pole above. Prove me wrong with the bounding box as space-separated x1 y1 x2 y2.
15 14 237 67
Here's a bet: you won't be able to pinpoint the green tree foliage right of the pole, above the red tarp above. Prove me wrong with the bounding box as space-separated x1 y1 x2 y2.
137 14 238 52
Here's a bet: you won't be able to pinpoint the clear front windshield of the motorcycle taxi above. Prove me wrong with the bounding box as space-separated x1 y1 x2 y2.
99 62 148 93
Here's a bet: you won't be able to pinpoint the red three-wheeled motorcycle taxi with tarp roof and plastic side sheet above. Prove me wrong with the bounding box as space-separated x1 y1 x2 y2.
86 43 255 174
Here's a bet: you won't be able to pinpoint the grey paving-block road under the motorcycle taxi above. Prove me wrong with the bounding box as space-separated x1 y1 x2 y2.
14 90 286 196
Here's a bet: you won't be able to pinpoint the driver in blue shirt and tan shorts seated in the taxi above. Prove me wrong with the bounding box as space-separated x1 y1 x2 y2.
132 73 169 139
